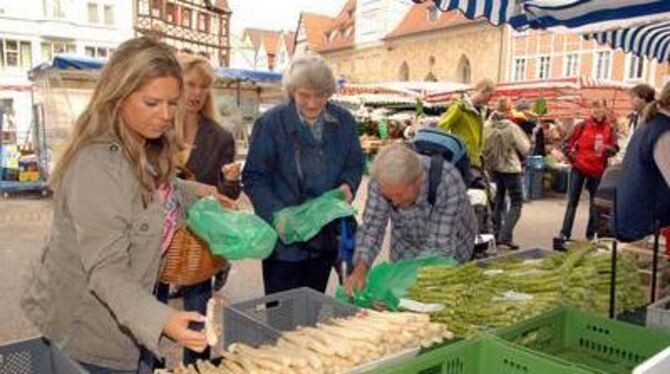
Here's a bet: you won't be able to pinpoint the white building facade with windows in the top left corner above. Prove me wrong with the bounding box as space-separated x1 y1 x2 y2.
0 0 133 139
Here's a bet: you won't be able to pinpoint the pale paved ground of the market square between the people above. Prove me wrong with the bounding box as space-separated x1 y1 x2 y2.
0 186 587 350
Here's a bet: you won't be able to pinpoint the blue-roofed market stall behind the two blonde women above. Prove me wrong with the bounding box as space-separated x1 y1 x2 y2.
30 55 281 166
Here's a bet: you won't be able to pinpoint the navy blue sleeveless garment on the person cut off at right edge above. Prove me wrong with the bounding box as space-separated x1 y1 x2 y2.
614 113 670 241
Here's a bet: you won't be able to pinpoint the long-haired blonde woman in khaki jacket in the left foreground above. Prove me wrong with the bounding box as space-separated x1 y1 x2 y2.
22 38 234 373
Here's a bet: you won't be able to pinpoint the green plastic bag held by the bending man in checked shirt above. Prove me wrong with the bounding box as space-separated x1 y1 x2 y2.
335 256 457 311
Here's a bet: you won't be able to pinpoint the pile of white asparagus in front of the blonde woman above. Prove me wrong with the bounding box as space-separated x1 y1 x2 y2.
156 311 454 374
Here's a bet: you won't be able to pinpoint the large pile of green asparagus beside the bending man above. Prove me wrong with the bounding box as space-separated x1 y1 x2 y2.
409 243 644 336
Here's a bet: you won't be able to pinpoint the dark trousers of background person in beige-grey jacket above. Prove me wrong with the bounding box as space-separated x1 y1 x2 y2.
492 172 523 243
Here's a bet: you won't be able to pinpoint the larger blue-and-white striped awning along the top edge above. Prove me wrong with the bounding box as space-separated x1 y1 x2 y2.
414 0 670 30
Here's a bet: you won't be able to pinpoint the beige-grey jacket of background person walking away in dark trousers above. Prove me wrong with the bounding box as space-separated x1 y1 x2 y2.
484 116 530 174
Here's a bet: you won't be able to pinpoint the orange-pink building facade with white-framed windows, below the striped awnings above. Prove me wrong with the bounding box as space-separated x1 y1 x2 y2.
503 31 668 88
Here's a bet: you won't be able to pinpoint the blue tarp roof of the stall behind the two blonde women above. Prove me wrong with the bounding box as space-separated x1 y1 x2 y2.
30 55 282 82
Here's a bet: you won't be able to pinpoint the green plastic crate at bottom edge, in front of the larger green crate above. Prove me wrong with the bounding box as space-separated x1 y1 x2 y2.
373 336 589 374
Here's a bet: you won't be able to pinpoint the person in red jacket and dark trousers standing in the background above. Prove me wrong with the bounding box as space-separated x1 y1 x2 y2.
560 99 619 241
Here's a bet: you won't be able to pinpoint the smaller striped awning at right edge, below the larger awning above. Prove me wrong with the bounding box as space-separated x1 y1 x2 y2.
583 18 670 62
